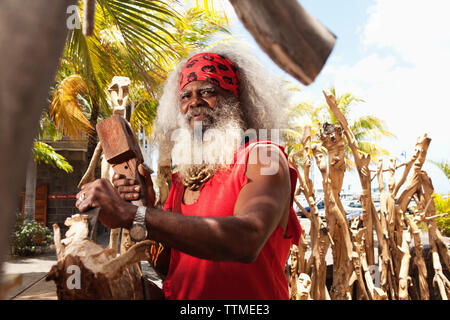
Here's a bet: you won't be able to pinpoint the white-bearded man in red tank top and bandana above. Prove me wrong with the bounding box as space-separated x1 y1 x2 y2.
77 44 301 299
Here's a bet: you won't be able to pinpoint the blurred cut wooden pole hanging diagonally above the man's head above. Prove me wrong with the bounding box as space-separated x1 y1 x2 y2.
230 0 336 85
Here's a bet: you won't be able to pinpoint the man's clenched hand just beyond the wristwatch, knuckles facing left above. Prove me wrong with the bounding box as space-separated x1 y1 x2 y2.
75 179 137 229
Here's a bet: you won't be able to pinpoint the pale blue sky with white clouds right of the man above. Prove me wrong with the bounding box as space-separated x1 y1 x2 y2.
220 0 450 193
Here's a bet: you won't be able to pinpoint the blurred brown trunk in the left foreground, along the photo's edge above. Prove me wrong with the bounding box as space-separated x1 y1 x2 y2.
0 0 76 284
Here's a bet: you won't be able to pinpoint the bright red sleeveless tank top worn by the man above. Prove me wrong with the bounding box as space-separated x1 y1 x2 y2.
163 141 302 300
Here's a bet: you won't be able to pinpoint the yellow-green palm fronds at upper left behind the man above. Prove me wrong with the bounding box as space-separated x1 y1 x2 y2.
49 0 227 158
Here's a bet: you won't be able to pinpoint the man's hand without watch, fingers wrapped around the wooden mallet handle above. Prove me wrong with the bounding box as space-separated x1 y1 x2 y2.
112 164 156 207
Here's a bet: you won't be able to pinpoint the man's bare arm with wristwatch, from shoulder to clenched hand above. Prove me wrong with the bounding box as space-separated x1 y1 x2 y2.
77 146 291 263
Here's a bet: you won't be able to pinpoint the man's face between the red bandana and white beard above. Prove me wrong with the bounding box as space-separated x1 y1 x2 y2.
179 80 227 128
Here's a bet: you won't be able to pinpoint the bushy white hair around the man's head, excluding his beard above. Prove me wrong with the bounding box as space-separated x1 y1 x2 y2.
152 40 289 164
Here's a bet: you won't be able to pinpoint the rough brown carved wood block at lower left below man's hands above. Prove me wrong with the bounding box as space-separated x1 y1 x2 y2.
46 214 153 300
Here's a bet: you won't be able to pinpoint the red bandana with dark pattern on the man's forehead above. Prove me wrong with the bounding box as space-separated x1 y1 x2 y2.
178 52 239 97
